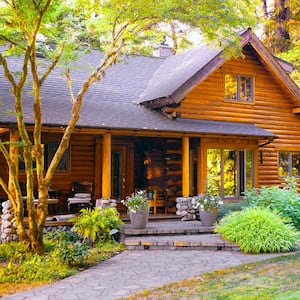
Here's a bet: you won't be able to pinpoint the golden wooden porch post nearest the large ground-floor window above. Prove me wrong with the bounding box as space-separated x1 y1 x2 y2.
182 136 190 197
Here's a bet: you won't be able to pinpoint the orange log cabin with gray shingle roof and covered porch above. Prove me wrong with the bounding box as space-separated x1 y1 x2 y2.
0 29 300 213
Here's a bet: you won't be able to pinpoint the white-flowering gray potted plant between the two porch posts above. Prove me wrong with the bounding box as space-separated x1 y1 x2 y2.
122 191 150 229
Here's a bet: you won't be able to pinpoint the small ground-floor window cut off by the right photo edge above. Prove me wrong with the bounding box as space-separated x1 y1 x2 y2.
278 152 300 177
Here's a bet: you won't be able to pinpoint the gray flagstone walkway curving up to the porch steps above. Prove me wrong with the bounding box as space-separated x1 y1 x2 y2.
1 250 294 300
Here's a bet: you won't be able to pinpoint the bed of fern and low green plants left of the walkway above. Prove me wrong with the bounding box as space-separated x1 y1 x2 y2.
0 208 124 298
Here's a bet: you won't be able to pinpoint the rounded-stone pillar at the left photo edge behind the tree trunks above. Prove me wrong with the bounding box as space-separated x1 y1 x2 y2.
1 200 18 243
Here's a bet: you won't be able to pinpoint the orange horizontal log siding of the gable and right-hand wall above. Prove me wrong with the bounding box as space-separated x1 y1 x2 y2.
172 53 300 185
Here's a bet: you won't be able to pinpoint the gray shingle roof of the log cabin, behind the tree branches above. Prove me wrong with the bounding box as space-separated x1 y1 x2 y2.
0 48 274 137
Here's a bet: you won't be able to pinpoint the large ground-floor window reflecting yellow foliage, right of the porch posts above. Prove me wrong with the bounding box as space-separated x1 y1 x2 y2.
207 149 253 198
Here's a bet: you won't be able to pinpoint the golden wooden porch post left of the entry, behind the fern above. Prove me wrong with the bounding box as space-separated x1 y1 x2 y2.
102 133 111 198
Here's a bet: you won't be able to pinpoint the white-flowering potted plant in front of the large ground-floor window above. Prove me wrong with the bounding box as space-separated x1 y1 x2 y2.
192 192 223 226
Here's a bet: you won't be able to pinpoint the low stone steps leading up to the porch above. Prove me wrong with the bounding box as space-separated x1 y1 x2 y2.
121 221 240 251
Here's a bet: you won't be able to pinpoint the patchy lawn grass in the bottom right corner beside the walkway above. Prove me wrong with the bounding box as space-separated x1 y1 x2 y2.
128 253 300 300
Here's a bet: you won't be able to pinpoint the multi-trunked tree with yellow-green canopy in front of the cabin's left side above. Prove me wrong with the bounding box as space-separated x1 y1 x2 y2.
0 0 253 253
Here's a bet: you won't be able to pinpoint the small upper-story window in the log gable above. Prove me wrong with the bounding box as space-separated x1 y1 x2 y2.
224 74 254 103
